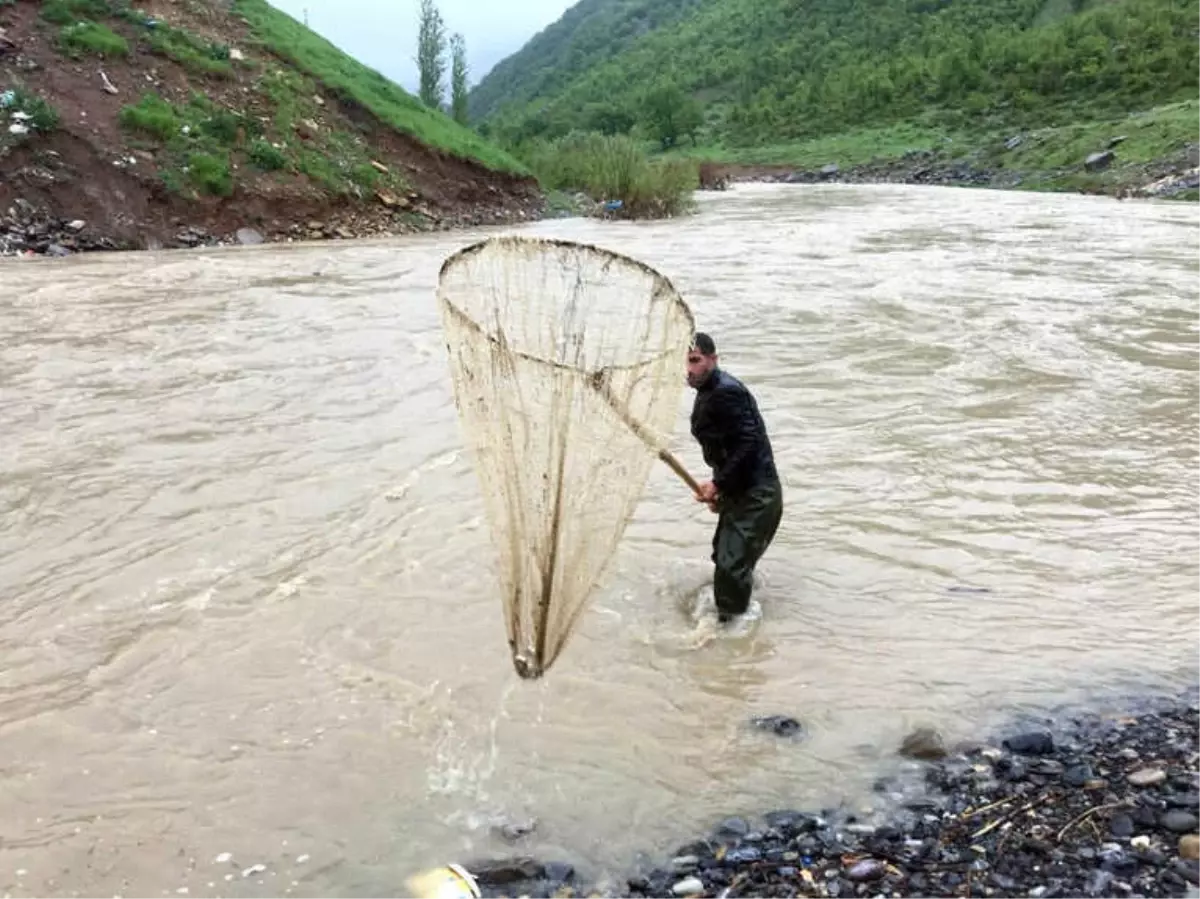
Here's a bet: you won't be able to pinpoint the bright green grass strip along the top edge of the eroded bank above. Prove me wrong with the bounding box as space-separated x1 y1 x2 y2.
234 0 528 174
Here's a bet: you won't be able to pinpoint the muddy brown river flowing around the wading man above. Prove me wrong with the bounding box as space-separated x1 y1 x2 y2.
0 186 1200 899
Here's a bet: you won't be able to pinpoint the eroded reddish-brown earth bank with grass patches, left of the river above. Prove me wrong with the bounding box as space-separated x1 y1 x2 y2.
0 0 544 252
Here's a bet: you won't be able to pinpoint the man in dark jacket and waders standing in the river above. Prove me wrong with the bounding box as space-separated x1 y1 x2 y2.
688 332 784 622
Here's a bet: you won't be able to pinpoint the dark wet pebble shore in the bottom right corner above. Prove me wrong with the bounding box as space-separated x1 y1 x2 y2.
453 681 1200 899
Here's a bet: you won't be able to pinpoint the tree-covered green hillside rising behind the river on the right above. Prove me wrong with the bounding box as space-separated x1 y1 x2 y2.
475 0 1200 168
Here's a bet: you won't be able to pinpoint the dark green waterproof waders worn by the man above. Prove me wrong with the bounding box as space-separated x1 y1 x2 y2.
713 479 784 615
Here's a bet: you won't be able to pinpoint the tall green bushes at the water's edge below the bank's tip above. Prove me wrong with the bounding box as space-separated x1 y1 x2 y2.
526 133 698 218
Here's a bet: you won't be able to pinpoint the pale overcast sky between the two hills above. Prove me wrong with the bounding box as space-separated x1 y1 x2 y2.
269 0 575 94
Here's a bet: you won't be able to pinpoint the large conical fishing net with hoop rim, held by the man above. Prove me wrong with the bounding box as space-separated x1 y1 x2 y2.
438 236 695 678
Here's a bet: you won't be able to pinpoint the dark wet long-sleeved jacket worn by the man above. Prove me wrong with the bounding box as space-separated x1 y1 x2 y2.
691 368 779 496
